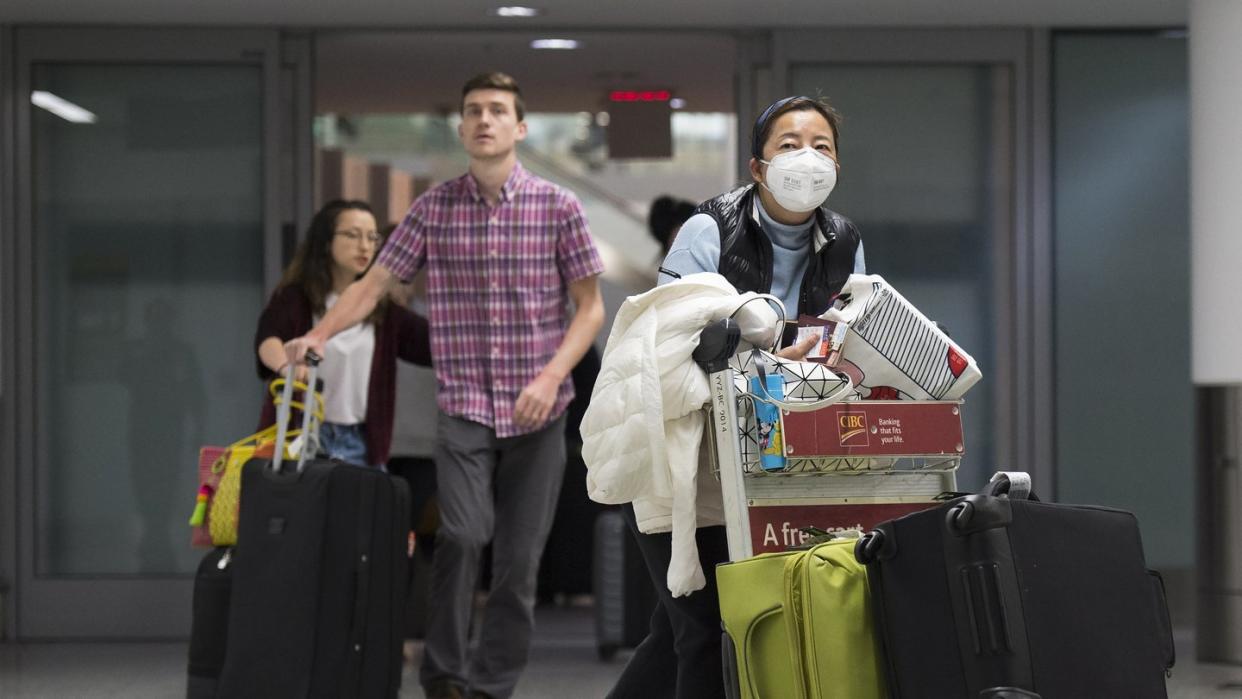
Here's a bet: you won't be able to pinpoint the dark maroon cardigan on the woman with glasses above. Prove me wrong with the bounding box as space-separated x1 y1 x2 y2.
255 287 431 463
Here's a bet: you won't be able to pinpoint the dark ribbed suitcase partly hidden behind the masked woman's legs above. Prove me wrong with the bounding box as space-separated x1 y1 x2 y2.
591 508 656 661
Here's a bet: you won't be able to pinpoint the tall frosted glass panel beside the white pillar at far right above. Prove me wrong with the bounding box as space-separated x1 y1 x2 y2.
1052 32 1196 571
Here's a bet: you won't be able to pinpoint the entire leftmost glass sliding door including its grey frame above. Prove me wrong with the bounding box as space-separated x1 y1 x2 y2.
10 30 290 638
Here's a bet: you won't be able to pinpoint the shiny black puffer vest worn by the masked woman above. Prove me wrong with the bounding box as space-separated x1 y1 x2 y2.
694 185 862 315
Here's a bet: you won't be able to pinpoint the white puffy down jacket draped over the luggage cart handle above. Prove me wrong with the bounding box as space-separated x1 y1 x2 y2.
581 273 776 596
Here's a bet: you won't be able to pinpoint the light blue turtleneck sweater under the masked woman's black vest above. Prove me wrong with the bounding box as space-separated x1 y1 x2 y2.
658 196 867 320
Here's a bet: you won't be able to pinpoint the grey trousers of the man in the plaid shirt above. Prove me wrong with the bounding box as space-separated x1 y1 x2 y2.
419 413 565 699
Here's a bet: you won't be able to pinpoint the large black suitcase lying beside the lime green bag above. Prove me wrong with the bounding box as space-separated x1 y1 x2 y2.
856 474 1174 699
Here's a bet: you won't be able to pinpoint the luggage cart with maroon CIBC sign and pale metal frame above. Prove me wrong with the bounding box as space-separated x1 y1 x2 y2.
696 322 965 561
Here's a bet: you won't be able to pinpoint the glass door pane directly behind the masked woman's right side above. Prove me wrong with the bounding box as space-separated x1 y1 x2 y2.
790 65 1009 483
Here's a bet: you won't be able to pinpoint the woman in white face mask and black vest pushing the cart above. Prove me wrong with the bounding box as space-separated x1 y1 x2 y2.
609 97 864 699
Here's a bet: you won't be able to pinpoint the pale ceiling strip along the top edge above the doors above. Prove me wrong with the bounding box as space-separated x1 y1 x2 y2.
0 0 1187 30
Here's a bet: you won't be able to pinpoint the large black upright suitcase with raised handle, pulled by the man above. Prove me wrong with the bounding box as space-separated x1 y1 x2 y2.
219 360 410 699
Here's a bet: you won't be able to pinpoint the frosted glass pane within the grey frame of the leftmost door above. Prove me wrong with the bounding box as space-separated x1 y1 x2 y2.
31 63 263 576
